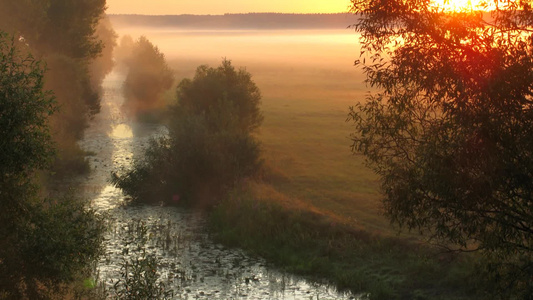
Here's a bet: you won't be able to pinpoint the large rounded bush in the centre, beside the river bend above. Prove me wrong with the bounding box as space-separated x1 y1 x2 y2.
113 60 262 206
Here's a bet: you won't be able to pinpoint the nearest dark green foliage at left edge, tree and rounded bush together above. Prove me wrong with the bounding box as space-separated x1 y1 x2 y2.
0 33 103 299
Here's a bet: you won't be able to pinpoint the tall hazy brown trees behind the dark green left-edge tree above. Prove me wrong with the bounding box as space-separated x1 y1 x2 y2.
0 0 116 174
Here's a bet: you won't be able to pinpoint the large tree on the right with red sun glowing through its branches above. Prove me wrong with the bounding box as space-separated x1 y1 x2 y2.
349 0 533 295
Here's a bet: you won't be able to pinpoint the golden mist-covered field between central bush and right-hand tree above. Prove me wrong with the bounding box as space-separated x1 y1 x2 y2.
114 28 390 232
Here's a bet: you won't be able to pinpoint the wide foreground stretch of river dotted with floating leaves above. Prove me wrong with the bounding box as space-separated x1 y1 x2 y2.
96 207 362 299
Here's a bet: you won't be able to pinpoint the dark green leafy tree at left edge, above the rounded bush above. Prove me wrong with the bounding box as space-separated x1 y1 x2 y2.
0 32 56 213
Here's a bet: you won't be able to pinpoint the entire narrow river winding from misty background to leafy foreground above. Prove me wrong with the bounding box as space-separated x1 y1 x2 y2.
81 72 362 299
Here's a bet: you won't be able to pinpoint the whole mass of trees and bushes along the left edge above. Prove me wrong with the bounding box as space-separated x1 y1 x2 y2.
0 0 116 299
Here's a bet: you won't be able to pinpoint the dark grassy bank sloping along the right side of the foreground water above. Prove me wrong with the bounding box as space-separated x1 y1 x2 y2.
210 183 482 299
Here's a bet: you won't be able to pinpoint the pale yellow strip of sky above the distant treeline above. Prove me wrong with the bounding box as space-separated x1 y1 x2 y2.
107 0 350 15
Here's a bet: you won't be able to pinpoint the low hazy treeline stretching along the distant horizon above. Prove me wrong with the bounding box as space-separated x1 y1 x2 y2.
109 13 356 29
